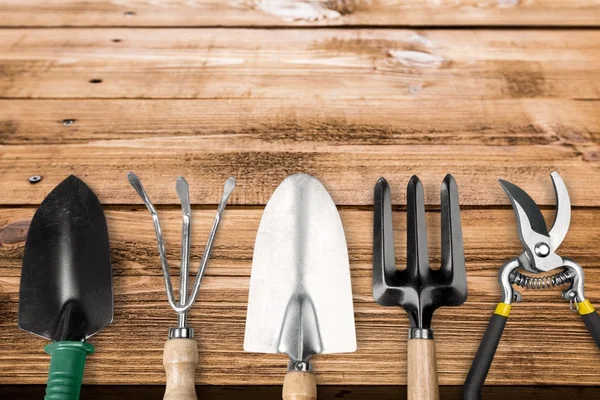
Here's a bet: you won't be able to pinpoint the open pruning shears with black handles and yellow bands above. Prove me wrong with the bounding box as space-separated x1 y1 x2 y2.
464 172 600 400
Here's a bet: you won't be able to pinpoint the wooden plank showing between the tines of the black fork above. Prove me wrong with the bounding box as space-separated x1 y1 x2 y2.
0 207 600 276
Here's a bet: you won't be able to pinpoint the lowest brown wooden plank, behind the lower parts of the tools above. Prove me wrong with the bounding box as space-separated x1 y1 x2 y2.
0 276 600 385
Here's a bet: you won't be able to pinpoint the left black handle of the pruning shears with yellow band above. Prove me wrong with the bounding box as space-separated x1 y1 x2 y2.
465 303 511 400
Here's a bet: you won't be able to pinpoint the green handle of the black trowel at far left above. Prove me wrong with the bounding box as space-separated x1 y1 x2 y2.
44 340 94 400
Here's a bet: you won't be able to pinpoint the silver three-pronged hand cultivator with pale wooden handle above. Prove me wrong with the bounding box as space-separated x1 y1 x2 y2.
127 172 235 400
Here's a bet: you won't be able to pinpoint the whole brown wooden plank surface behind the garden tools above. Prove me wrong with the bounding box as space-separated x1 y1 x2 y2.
0 0 600 398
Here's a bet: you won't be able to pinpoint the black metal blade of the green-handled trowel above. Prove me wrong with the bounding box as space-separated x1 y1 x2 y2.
19 175 113 341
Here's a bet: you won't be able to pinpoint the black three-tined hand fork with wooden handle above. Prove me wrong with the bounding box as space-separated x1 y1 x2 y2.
373 175 467 400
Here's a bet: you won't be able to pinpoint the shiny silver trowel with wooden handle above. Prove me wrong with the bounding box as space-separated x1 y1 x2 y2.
244 174 356 400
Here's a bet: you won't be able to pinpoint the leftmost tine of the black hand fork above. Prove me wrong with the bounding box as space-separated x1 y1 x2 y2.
373 178 396 285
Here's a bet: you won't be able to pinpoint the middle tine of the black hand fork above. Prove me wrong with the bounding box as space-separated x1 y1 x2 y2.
406 175 430 277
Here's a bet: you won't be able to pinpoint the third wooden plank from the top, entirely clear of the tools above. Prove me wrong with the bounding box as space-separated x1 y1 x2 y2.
0 97 600 147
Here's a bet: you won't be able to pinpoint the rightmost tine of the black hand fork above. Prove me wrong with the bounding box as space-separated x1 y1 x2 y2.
441 174 467 284
